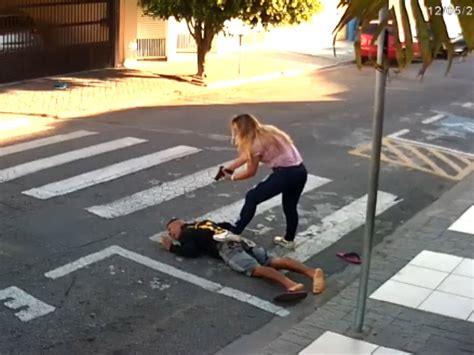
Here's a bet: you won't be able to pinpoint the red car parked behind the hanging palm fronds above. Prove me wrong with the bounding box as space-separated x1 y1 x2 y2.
360 20 421 61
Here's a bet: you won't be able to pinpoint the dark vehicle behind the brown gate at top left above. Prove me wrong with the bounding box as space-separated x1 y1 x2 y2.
0 11 43 53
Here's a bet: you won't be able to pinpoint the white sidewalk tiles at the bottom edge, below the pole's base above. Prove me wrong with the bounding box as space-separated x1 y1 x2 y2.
298 331 409 355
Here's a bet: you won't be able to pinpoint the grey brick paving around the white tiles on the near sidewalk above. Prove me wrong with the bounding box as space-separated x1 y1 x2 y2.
255 173 474 355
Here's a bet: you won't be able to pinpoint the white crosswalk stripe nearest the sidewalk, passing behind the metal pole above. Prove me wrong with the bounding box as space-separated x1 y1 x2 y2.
286 191 402 262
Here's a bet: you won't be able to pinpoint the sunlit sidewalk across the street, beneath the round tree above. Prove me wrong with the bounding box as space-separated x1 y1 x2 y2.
0 44 354 125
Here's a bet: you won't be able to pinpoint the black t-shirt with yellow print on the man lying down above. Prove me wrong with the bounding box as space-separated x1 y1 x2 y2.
170 221 223 259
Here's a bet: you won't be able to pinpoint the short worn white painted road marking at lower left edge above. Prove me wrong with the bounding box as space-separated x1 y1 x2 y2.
0 286 55 322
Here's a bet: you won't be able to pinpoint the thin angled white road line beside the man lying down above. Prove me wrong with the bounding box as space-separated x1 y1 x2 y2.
45 245 290 317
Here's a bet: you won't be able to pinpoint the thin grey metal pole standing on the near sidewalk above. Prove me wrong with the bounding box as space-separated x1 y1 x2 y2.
355 6 388 332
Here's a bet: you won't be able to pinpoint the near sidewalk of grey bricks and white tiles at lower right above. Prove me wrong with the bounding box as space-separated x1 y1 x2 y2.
256 174 474 355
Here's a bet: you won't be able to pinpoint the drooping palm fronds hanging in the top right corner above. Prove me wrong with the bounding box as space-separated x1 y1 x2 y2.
334 0 474 74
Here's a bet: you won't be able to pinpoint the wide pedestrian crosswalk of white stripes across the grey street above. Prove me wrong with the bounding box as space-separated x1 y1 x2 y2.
0 130 400 261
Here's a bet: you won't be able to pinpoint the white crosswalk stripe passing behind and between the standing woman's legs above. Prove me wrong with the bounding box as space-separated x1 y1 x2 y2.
149 175 331 242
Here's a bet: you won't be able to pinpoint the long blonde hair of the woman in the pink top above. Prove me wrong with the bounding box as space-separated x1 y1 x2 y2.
231 113 293 158
